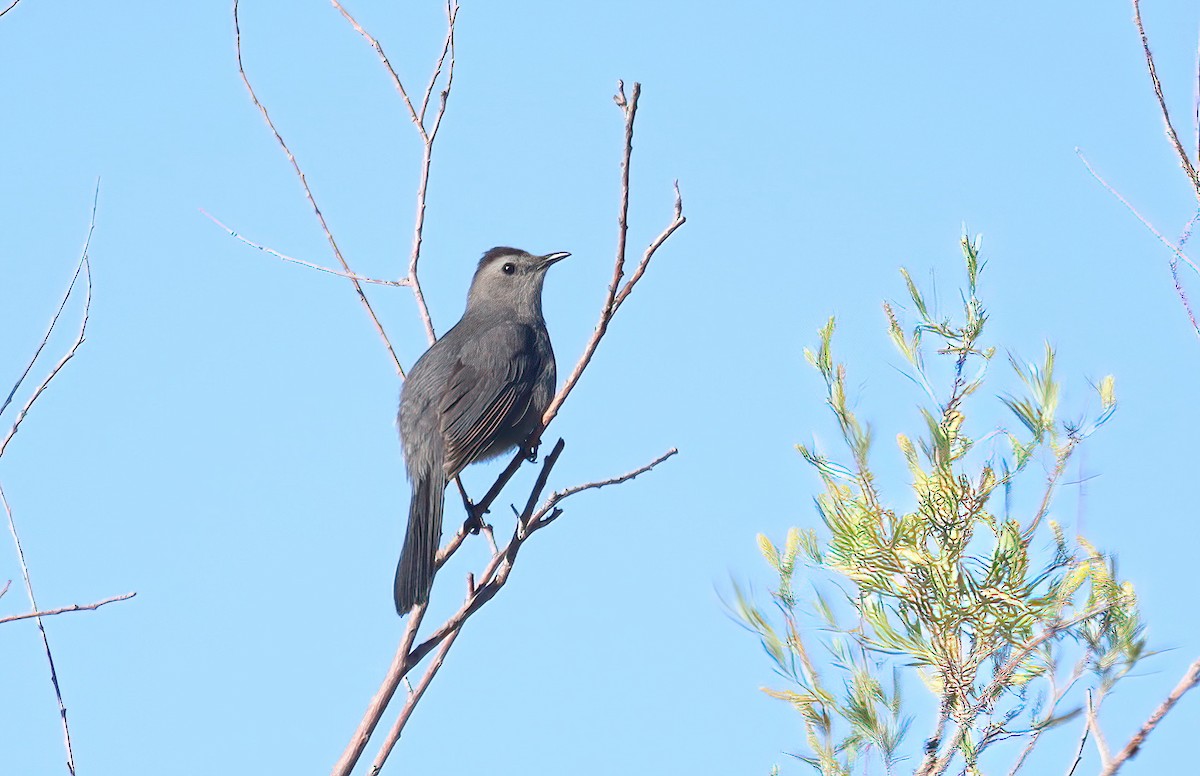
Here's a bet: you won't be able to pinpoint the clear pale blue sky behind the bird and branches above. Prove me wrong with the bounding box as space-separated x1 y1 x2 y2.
0 0 1200 776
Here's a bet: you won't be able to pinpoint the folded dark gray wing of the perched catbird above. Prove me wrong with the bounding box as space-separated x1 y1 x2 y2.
439 325 538 477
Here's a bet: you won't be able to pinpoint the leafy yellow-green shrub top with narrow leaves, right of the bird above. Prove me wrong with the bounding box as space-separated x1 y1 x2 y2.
733 237 1146 776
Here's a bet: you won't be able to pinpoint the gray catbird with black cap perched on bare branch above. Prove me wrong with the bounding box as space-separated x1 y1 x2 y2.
396 248 570 616
